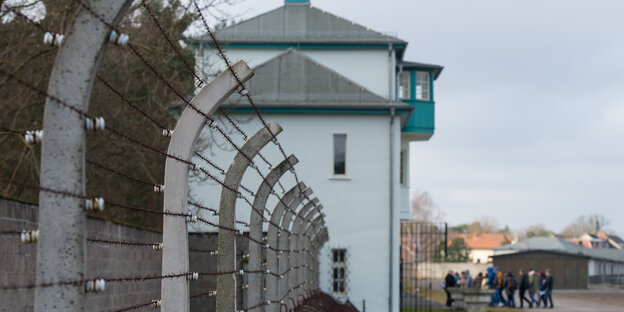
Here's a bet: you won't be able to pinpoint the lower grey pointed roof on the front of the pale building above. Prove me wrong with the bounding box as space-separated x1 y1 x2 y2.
223 49 412 111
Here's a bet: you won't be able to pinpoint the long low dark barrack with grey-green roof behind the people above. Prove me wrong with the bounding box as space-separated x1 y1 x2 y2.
493 237 624 289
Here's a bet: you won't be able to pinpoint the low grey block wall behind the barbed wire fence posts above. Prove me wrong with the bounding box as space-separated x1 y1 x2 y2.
0 199 254 312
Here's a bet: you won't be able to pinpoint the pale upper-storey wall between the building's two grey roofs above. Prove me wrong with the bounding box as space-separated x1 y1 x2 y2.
197 48 394 98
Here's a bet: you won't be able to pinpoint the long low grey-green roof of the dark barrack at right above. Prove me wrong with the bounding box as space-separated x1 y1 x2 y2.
494 237 624 262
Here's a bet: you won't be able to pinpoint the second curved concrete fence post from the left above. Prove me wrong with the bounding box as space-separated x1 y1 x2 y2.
161 61 253 312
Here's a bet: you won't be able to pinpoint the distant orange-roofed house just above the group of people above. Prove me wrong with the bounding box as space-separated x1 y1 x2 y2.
448 233 511 263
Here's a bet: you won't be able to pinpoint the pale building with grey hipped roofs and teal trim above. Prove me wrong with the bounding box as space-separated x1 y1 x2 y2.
190 0 442 311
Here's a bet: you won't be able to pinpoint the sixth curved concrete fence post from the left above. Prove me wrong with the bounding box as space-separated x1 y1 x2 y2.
277 188 312 309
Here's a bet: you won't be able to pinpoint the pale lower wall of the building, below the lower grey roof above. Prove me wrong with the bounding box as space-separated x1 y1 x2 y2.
189 114 401 312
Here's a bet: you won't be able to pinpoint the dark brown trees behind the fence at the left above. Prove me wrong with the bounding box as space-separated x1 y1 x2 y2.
0 0 241 229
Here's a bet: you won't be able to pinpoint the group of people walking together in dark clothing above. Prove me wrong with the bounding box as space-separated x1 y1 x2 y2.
443 267 554 309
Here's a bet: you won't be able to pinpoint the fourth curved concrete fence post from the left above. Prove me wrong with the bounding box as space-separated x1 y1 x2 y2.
247 155 299 307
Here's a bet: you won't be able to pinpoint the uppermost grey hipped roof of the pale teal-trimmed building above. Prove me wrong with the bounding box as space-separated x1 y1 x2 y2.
200 3 407 44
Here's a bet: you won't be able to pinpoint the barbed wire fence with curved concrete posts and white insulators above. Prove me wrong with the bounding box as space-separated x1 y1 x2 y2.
0 0 328 311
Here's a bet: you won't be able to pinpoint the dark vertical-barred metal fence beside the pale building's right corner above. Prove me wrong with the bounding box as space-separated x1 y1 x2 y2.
400 221 447 311
